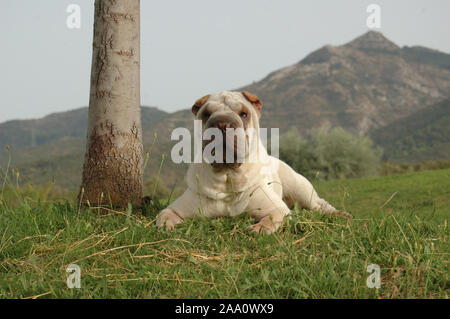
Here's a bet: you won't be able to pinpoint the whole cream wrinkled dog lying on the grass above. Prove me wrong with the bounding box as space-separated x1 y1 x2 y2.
157 91 350 234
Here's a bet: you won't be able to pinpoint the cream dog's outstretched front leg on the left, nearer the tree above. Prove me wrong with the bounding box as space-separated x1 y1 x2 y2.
156 189 198 231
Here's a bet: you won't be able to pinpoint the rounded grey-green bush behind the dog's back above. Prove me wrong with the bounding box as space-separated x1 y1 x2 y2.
280 126 381 180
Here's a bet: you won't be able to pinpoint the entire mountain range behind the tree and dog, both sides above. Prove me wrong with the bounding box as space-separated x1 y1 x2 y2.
0 31 450 188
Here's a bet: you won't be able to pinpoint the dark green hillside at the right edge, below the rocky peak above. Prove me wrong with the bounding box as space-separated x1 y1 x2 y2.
370 99 450 161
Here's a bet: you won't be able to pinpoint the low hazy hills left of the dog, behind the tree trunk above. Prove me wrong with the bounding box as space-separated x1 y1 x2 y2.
0 106 185 188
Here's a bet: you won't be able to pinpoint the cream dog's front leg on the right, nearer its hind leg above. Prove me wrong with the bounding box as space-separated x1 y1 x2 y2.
246 186 290 235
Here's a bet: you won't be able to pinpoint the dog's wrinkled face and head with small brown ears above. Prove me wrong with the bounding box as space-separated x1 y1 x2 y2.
192 91 262 169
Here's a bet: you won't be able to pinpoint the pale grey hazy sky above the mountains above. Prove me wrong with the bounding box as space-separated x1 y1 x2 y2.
0 0 450 122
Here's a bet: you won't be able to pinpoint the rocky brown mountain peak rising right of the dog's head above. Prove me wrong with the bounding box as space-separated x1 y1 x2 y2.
243 31 450 135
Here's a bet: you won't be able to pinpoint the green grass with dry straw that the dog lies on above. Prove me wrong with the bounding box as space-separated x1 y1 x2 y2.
0 170 450 298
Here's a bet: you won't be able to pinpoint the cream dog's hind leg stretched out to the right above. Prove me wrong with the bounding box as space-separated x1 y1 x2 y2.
278 161 352 218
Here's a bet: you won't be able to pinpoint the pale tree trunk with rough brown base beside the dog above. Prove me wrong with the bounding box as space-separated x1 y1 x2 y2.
78 0 143 207
